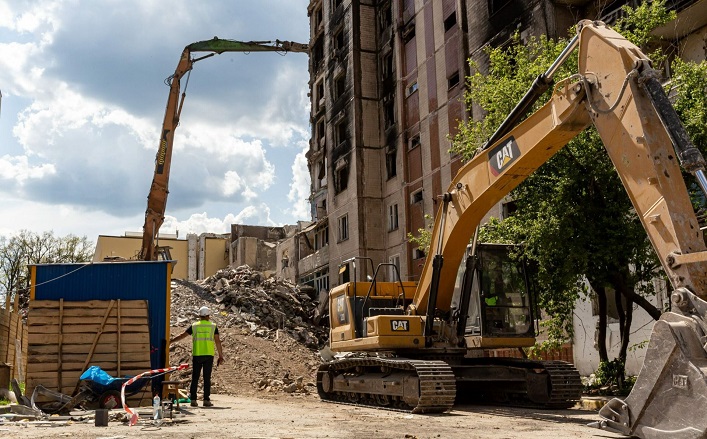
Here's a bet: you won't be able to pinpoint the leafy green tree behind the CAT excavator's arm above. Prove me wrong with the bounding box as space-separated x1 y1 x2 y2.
452 1 707 384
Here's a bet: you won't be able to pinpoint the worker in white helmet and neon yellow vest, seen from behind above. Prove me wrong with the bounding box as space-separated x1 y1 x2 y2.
169 306 225 407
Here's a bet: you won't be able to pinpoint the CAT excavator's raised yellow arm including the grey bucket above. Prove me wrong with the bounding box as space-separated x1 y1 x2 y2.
408 21 707 439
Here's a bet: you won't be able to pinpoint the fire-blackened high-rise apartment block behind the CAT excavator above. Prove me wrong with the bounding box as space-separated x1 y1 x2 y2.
299 0 706 286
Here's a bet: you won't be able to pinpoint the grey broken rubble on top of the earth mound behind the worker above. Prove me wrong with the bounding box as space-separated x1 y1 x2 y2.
171 265 328 350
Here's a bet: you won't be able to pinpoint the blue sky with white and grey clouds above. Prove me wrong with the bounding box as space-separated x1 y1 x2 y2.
0 0 309 240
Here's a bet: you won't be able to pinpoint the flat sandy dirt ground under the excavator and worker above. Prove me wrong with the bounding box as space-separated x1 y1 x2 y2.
0 394 621 439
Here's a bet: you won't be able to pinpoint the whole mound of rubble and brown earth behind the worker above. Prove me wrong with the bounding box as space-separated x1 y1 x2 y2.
170 265 328 397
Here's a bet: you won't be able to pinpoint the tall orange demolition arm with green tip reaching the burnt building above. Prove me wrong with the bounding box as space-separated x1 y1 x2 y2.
138 37 309 261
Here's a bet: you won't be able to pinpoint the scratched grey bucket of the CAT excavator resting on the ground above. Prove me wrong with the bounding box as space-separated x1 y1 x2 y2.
589 288 707 439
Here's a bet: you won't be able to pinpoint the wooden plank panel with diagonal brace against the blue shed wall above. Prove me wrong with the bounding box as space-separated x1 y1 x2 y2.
26 299 151 403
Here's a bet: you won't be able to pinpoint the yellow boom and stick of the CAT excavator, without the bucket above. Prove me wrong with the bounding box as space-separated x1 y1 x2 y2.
409 21 707 320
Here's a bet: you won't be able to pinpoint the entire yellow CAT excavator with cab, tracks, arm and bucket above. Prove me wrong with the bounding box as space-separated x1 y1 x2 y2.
317 20 707 438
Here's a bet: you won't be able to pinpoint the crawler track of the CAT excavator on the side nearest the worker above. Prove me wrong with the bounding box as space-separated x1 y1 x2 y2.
317 357 456 413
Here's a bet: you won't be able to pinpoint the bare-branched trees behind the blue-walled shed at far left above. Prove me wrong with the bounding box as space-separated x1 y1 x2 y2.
0 230 94 308
